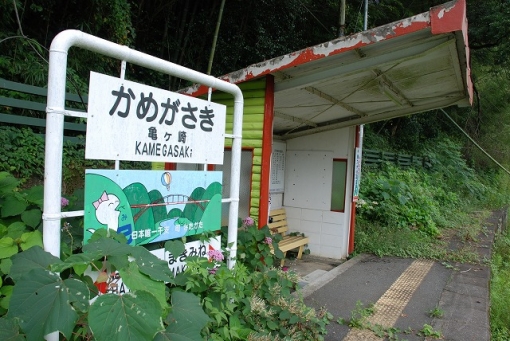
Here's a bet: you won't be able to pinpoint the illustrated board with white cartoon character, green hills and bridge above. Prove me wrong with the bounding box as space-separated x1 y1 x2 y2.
84 169 222 245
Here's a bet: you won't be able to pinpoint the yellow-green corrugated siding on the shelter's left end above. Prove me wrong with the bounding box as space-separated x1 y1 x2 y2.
211 79 266 218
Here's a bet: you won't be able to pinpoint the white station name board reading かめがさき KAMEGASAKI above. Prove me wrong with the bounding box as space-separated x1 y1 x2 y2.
85 72 226 164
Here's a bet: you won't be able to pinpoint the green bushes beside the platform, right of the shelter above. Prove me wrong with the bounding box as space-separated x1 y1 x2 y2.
355 137 510 261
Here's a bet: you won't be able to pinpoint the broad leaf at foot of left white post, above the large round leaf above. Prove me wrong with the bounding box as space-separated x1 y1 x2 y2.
9 246 62 282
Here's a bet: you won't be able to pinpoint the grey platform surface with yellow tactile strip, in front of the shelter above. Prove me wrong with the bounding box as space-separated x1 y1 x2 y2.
286 209 506 341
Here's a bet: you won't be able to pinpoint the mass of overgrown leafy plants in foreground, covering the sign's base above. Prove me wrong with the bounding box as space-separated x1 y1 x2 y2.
0 173 331 341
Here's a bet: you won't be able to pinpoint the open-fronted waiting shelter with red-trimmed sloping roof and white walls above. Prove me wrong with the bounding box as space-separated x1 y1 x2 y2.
178 0 473 259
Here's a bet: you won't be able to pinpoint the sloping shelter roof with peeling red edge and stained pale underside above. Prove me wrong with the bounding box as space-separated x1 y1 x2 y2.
186 0 472 139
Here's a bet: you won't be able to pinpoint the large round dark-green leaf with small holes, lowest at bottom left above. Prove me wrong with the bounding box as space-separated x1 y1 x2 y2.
9 269 89 340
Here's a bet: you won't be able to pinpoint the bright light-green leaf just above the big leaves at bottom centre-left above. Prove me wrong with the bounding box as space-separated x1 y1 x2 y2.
119 262 167 308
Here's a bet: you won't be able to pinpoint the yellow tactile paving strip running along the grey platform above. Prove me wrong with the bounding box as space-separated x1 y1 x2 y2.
343 260 434 341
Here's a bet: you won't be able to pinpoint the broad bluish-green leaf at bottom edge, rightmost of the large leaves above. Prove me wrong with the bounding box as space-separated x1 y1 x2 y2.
154 291 209 341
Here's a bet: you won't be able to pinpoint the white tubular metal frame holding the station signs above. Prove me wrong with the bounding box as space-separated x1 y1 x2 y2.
43 30 244 268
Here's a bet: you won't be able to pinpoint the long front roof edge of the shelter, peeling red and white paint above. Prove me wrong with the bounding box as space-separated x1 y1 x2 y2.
179 10 434 96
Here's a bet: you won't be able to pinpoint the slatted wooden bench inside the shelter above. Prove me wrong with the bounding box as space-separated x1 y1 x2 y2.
267 208 308 266
